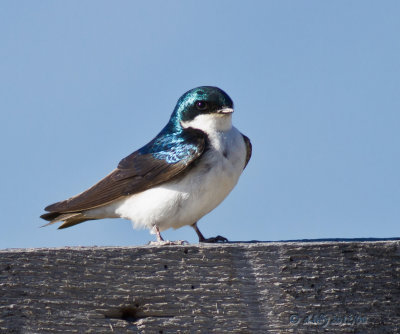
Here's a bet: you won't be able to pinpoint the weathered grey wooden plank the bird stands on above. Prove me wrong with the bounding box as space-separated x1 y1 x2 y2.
0 241 400 334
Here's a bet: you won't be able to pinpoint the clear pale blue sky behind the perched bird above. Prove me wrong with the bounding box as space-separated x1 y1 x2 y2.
0 0 400 248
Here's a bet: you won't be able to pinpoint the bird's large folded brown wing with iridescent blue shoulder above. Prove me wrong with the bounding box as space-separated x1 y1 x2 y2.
42 129 206 214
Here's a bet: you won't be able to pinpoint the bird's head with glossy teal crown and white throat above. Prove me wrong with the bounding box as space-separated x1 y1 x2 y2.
170 86 233 133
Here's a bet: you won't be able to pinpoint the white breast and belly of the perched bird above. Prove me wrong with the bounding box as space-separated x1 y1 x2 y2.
91 127 246 231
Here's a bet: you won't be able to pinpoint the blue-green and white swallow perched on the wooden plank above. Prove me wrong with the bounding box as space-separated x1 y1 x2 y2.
40 86 252 244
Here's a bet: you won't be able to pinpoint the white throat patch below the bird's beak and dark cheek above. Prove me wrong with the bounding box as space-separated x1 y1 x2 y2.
181 114 232 133
